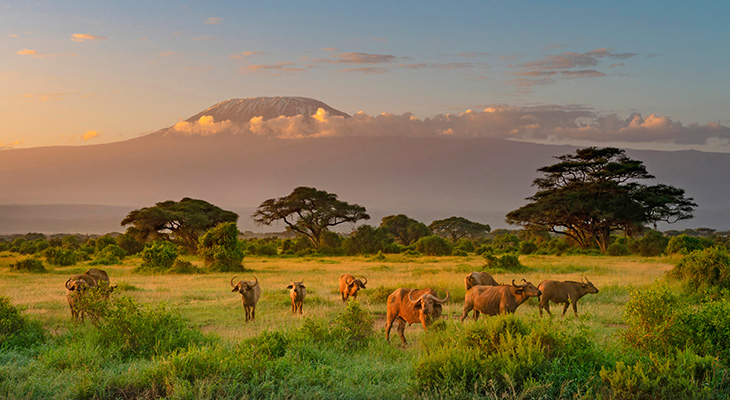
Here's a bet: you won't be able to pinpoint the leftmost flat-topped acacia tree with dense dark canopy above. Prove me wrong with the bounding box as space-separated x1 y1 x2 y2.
122 197 238 253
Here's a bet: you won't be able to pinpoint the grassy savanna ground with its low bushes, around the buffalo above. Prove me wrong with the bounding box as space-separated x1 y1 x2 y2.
5 252 730 399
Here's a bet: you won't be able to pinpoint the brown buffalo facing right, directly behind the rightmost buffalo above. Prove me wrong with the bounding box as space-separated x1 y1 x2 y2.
461 279 542 321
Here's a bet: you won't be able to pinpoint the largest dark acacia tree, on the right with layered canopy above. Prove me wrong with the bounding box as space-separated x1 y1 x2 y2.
507 147 697 253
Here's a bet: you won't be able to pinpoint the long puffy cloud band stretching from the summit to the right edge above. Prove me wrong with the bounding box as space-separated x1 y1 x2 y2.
216 105 730 145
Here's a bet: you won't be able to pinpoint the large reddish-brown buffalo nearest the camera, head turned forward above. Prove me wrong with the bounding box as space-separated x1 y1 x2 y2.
385 288 450 346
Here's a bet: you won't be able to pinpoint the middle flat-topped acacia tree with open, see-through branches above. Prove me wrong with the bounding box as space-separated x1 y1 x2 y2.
253 186 370 249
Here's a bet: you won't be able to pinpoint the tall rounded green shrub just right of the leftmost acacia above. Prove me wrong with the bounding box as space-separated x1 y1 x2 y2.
198 222 243 272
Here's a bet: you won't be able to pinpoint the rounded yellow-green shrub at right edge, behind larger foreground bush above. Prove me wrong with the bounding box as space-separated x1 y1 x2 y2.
669 247 730 289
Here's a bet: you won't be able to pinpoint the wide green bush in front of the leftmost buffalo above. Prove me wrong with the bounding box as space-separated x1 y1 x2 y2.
95 296 209 358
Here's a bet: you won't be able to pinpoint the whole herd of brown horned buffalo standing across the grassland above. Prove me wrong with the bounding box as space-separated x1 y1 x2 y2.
61 268 598 345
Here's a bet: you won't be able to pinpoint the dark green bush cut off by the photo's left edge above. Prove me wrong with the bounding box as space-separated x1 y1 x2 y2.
0 297 45 349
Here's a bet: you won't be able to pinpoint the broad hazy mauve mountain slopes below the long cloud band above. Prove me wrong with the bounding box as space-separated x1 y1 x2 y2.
0 100 730 234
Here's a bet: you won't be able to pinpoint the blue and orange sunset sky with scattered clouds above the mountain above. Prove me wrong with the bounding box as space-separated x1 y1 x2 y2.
0 0 730 152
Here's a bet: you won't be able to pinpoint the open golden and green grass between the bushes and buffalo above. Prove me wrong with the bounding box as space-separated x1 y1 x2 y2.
0 253 712 399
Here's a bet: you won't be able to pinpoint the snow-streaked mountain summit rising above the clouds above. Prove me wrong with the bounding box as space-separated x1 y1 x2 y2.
186 96 350 125
